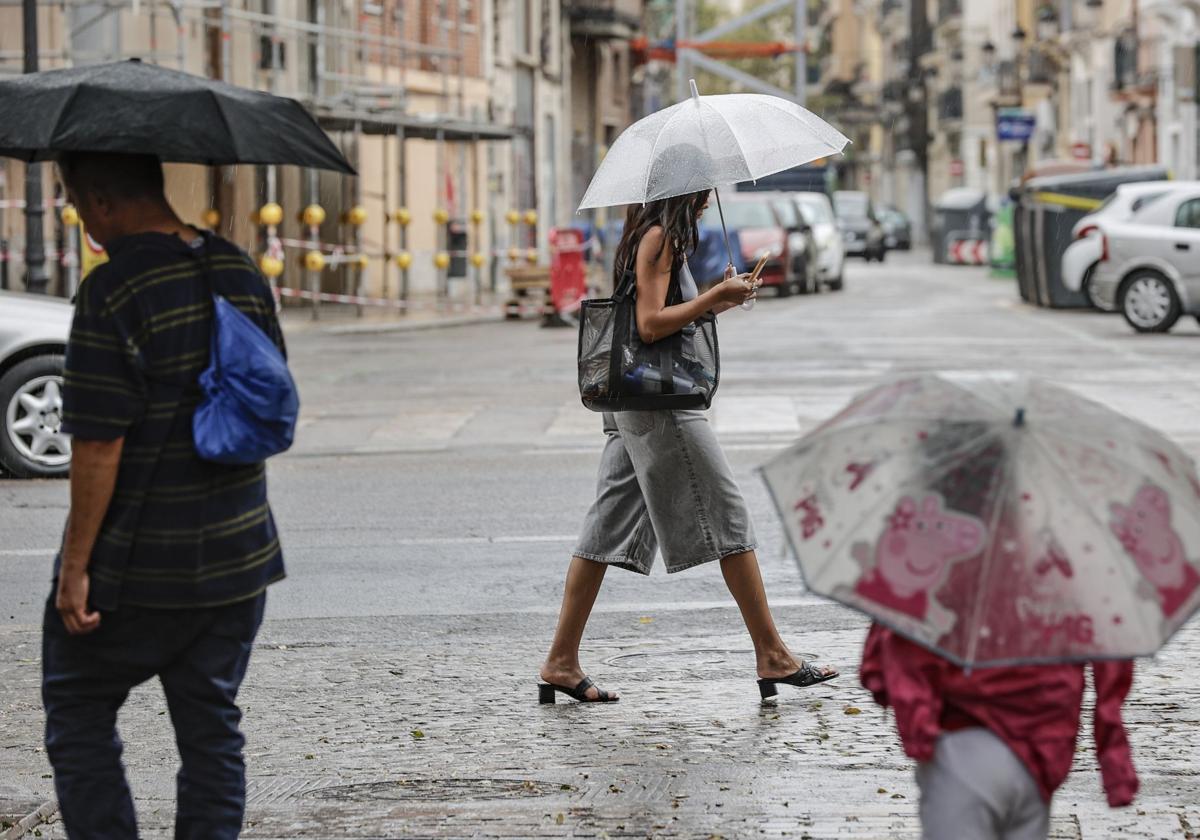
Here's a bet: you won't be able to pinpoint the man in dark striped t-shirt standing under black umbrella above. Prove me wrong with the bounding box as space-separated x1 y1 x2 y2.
42 154 283 840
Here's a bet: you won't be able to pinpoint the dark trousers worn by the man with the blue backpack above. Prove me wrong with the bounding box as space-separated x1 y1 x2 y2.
42 594 266 840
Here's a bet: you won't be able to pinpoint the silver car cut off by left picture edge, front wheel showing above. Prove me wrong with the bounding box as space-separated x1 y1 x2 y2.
0 292 74 478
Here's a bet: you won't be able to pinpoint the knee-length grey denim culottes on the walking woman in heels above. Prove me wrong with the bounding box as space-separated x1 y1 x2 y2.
575 410 755 575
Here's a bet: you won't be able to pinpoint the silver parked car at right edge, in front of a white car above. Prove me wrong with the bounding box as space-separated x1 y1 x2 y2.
1091 184 1200 332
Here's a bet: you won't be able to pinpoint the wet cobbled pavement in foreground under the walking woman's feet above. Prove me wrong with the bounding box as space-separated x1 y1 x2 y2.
0 602 1200 840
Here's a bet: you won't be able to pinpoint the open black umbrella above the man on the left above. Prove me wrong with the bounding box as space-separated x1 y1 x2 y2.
0 59 356 175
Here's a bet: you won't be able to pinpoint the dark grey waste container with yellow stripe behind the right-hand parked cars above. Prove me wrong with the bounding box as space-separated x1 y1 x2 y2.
1013 167 1170 308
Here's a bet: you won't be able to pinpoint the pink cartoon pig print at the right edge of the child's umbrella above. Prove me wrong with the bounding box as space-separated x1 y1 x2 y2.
1109 484 1200 618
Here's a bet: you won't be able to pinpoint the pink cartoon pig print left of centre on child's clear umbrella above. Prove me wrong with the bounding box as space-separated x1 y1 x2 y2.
854 493 988 630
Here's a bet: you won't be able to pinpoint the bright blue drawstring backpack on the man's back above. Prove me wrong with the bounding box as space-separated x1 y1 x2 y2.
192 252 300 464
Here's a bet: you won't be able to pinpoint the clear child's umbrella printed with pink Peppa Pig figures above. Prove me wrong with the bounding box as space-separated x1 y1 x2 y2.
762 376 1200 666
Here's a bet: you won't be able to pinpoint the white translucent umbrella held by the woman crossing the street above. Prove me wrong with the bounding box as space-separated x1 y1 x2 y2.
578 82 850 263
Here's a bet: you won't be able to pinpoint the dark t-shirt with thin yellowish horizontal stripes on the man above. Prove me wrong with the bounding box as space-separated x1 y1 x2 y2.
62 233 283 610
